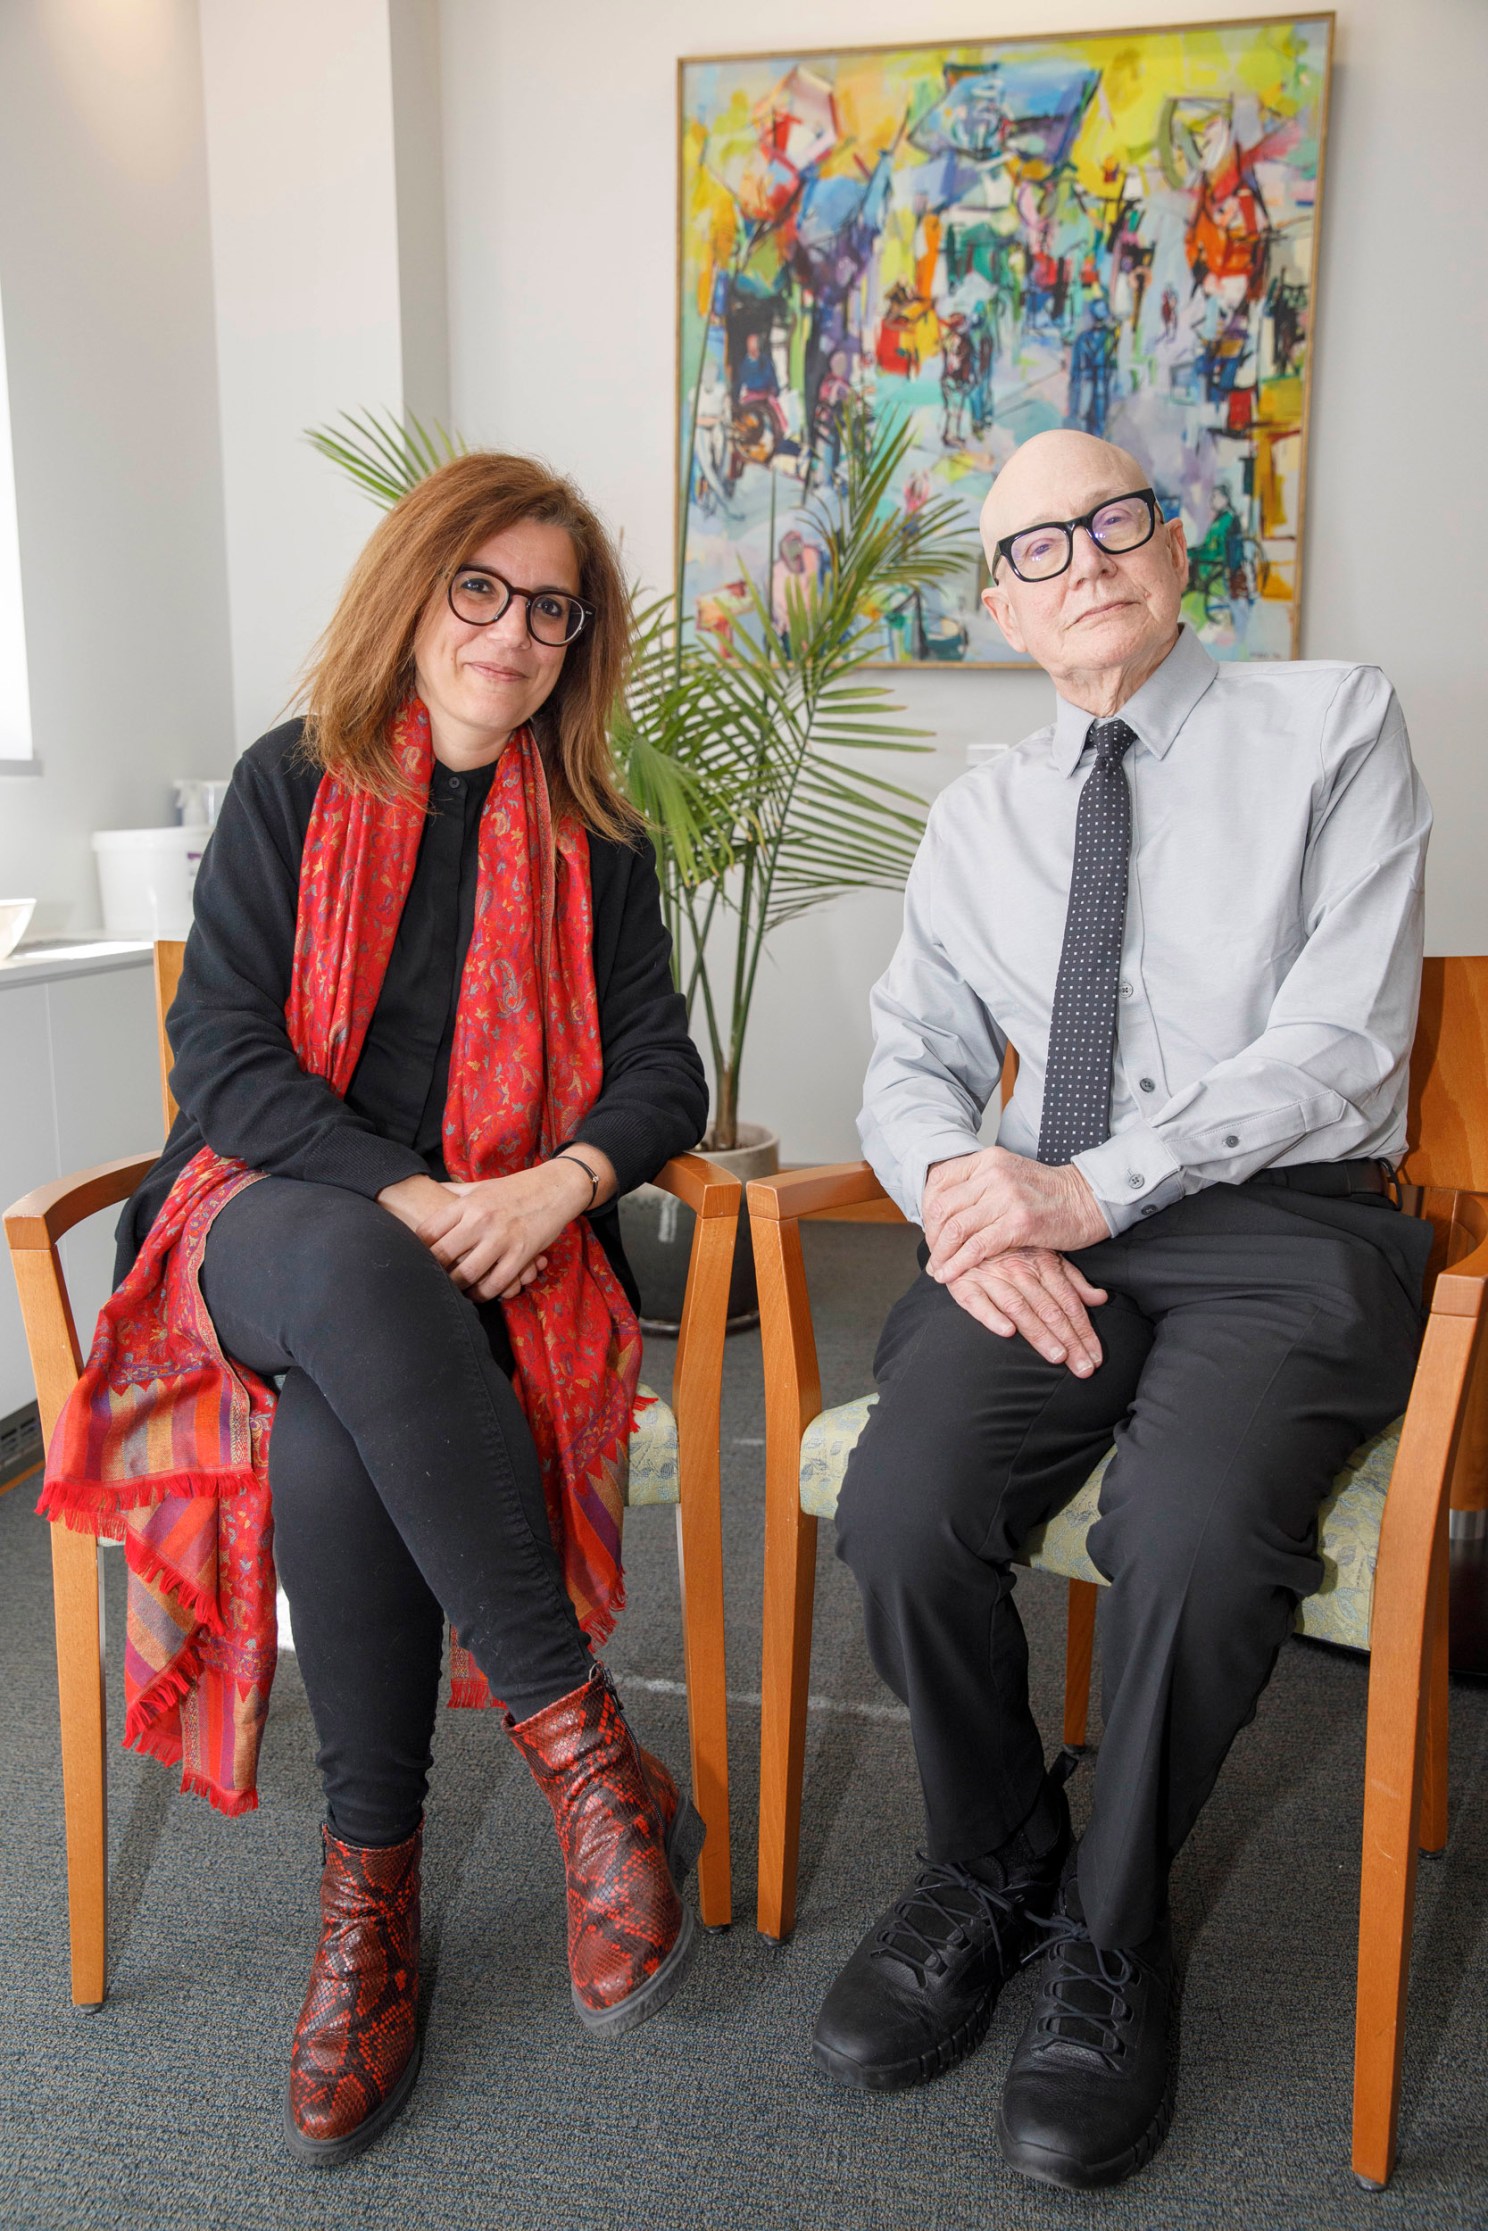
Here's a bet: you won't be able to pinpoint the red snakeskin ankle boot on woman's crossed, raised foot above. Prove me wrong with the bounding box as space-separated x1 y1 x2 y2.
506 1664 703 2037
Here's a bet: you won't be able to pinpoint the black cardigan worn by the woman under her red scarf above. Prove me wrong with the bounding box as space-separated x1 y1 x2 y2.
116 721 707 1298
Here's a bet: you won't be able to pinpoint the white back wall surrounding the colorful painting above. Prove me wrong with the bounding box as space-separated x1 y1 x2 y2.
442 0 1488 1160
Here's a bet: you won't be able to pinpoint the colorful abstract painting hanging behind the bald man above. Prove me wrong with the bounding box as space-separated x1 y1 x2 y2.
678 16 1332 665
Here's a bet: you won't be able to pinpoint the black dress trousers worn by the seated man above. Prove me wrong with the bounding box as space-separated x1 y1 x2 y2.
837 1185 1430 1948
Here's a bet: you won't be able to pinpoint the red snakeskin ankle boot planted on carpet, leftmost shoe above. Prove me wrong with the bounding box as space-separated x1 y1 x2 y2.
283 1829 424 2169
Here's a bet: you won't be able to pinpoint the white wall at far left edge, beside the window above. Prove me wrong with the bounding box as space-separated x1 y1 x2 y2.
0 0 232 930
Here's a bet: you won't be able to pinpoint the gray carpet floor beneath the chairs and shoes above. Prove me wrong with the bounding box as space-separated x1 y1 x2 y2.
0 1227 1488 2231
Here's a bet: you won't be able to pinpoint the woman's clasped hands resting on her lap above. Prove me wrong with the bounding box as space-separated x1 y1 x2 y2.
377 1147 613 1301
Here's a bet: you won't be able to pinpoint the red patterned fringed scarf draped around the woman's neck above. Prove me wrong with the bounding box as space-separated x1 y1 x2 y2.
40 701 640 1812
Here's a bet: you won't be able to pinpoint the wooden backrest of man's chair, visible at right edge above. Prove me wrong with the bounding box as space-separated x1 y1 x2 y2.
1401 953 1488 1194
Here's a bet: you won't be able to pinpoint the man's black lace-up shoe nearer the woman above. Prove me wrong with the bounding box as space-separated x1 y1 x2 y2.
812 1789 1071 2090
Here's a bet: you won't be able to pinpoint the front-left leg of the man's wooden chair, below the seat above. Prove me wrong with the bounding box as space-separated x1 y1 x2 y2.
759 1493 817 1941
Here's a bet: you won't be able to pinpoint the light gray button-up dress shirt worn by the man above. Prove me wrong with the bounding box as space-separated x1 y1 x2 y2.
859 627 1430 1232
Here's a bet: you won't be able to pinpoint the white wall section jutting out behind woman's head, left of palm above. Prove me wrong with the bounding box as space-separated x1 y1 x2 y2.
201 0 448 747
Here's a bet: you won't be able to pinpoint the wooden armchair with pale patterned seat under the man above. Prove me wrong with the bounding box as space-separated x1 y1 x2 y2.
750 959 1488 2186
